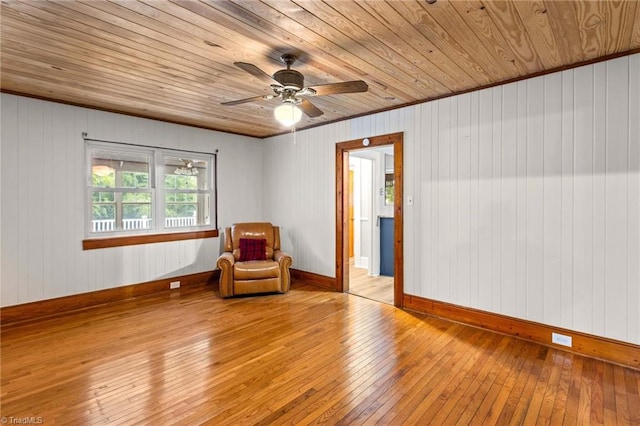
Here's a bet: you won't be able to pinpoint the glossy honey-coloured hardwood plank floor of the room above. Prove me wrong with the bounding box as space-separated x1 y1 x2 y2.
0 282 640 425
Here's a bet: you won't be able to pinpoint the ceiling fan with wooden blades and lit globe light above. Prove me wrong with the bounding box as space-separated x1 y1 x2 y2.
222 54 369 125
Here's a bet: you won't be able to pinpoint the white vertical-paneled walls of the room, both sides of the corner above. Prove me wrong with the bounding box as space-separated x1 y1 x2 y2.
0 54 640 344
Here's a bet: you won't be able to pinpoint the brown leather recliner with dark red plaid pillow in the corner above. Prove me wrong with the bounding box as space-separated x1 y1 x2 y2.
217 222 293 297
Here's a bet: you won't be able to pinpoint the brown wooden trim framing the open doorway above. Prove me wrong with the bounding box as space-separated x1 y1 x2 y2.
336 132 404 308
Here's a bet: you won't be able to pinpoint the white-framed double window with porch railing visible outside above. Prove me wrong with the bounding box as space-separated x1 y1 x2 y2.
87 141 215 238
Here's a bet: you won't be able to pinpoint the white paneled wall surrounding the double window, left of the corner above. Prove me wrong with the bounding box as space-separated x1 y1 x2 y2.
0 94 264 306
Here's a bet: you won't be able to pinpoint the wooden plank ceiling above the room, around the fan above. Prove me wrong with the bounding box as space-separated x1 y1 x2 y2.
1 0 640 137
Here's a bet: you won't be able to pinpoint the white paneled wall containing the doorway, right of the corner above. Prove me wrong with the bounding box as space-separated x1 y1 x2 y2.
265 54 640 344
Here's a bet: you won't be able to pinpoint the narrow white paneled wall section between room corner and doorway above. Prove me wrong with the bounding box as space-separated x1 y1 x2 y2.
264 122 348 276
